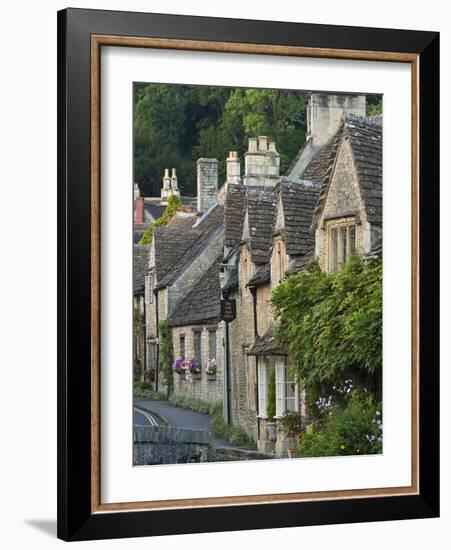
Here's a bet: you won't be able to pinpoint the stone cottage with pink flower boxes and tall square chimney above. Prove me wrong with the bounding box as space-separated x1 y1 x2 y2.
146 159 224 401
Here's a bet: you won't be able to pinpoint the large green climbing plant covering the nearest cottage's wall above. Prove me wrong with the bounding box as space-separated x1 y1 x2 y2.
272 258 382 396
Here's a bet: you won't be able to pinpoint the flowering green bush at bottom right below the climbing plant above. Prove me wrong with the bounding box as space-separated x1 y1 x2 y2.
298 390 382 457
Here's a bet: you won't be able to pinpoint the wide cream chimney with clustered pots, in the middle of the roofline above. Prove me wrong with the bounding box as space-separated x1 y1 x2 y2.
244 136 280 186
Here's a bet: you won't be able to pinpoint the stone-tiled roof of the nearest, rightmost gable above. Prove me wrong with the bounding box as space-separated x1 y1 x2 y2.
310 113 382 229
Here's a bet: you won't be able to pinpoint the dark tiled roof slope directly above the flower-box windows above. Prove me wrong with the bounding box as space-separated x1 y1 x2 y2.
169 255 222 326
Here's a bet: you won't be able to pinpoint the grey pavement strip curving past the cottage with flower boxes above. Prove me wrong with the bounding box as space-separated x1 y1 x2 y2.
134 397 233 448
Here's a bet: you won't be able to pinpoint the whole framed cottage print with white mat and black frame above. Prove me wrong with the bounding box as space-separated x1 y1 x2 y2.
58 9 439 540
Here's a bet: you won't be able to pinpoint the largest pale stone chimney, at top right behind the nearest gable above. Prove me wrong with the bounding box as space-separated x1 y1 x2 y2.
306 92 366 149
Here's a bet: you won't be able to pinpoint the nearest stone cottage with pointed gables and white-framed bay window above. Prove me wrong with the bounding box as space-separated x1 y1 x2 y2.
222 93 382 455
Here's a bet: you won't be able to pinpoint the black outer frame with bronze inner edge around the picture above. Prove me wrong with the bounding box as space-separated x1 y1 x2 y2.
58 8 439 540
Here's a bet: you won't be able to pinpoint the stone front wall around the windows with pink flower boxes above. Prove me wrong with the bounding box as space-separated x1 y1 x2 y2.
172 323 223 403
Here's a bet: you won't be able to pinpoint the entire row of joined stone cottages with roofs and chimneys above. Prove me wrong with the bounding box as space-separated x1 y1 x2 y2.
136 93 382 456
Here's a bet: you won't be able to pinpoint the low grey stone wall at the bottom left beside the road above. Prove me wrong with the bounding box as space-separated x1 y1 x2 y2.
133 426 211 466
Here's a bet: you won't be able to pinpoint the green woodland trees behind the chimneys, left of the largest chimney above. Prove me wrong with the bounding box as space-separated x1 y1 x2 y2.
133 83 308 196
